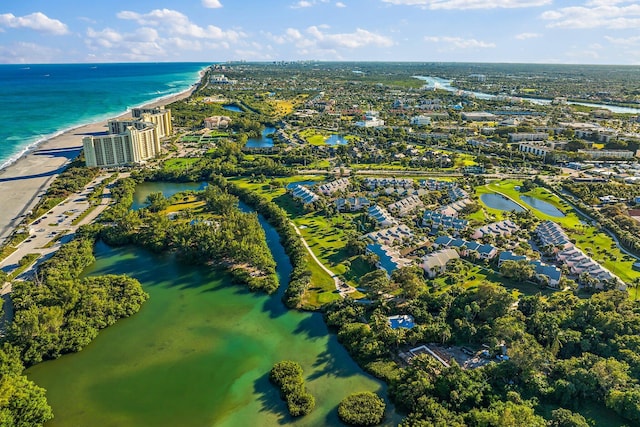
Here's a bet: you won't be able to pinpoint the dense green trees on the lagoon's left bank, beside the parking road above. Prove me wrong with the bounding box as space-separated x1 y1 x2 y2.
8 239 148 365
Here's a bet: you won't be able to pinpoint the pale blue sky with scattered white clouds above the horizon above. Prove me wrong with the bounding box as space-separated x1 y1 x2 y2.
0 0 640 65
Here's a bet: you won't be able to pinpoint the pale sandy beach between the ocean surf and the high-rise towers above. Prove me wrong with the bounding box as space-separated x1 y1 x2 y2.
0 79 204 244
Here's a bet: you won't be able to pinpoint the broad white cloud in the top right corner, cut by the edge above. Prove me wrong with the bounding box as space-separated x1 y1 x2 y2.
541 0 640 30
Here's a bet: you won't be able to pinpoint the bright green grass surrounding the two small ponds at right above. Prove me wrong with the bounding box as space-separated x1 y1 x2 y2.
476 179 640 283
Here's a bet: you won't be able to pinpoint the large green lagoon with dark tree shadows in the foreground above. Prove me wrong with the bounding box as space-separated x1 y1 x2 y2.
27 184 397 427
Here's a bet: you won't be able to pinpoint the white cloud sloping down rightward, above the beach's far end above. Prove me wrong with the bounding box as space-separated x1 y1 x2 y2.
117 9 246 42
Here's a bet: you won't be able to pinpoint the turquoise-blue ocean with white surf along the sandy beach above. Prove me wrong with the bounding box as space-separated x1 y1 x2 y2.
0 63 210 169
